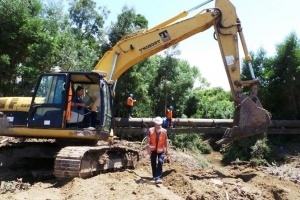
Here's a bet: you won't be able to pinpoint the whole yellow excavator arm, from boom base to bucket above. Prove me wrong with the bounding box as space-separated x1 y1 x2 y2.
94 0 270 143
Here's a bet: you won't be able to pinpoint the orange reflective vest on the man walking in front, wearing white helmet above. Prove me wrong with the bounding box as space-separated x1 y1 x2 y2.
149 127 168 153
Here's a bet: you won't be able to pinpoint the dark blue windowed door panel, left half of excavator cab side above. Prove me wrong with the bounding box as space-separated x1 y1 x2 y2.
28 74 67 128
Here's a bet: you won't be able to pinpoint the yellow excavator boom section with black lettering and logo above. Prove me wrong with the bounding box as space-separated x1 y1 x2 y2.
94 9 219 80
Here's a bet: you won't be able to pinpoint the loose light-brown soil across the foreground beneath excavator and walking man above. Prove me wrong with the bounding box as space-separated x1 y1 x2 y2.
0 138 300 200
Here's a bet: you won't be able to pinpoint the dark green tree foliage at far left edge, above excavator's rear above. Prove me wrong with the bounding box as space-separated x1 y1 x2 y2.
0 0 42 96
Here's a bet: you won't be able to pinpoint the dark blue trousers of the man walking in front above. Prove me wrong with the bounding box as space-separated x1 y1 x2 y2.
150 151 165 180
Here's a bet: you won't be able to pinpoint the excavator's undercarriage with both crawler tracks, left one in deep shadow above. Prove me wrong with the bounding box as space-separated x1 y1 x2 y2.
0 138 140 181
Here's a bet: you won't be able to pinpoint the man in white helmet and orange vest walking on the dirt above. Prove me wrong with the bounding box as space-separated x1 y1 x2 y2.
148 117 168 184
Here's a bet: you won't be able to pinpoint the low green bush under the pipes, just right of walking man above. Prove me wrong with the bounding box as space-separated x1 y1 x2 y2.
169 133 212 154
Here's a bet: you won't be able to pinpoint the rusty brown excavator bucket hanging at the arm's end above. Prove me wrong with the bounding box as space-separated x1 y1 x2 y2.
217 96 271 144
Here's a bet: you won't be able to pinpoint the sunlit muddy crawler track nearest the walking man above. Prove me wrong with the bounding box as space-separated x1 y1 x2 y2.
54 145 139 178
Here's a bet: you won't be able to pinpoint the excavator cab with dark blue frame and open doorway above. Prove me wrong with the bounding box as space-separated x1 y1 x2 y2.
28 72 112 133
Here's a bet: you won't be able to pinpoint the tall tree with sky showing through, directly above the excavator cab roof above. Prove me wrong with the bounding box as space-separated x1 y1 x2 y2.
69 0 110 71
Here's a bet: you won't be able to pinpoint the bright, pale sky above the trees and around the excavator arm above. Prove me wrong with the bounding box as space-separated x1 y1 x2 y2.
96 0 300 90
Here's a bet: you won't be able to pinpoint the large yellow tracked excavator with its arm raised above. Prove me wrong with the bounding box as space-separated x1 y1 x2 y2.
0 0 270 178
